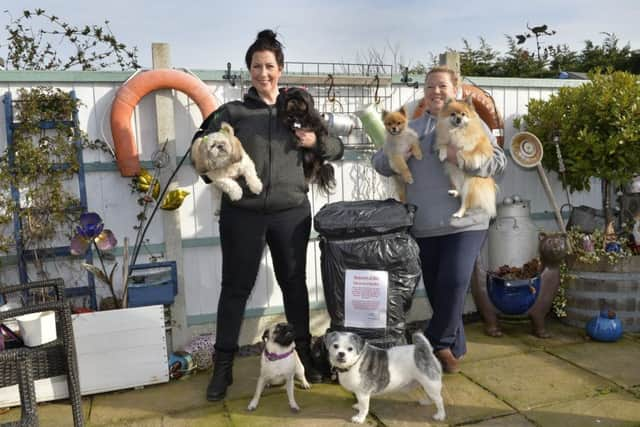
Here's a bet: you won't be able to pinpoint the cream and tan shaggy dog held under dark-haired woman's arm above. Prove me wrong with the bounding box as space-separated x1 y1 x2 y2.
191 122 262 200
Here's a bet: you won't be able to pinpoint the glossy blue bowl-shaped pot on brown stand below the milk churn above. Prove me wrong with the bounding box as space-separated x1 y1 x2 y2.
487 274 540 314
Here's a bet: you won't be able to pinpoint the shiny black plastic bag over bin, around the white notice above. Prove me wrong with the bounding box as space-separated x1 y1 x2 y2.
314 199 422 347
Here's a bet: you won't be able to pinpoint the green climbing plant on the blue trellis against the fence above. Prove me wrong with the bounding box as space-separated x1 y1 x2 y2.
0 87 82 266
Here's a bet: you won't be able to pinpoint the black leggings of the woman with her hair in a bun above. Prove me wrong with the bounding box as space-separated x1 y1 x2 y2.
215 199 311 351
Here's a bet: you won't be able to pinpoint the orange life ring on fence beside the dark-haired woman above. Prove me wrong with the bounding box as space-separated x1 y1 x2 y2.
111 69 217 176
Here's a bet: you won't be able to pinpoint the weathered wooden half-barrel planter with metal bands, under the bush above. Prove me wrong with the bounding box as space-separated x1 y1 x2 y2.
563 256 640 332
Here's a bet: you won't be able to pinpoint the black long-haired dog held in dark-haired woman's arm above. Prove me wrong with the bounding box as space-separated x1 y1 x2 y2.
277 87 336 194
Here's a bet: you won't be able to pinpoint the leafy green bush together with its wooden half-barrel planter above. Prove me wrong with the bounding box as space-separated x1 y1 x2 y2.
515 70 640 328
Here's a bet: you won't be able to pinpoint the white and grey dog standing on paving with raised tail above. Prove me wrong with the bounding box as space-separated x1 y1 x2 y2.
325 332 446 424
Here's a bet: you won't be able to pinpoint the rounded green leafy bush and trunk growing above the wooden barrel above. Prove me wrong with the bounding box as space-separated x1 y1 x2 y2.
515 71 640 229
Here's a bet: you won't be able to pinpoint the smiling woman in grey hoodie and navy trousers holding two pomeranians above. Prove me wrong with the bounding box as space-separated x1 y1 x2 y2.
372 67 506 373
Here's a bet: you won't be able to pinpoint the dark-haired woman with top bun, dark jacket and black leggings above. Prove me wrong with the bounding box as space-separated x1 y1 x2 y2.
194 30 343 401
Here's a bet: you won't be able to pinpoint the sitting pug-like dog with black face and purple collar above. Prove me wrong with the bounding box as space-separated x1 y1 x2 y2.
247 323 311 412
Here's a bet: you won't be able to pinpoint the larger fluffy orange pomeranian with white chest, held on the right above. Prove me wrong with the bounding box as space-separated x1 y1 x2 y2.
436 97 496 218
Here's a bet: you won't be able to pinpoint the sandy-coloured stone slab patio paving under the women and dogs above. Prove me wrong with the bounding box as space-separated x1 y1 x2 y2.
0 321 640 427
